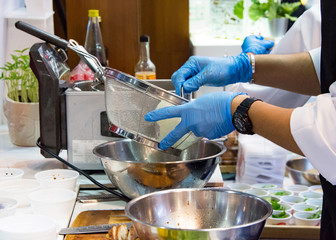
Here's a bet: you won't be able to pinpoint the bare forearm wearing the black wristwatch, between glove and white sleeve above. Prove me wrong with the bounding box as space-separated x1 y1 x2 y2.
231 95 303 155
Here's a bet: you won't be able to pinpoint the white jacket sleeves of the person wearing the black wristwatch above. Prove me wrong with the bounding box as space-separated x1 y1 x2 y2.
290 48 336 185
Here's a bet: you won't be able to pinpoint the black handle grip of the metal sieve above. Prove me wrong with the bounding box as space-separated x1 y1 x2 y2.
15 21 69 49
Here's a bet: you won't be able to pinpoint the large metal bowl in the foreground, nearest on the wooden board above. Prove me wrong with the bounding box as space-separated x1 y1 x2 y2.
125 188 272 240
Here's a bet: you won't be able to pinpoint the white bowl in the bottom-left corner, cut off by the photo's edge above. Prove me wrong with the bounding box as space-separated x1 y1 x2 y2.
0 214 57 240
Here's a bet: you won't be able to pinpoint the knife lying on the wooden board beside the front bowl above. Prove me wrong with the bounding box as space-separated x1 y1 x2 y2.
58 222 132 235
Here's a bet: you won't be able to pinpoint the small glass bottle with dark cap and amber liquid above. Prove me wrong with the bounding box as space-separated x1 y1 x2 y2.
134 35 156 80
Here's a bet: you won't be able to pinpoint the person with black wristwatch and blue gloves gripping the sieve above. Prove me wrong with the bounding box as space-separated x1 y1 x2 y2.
145 0 336 239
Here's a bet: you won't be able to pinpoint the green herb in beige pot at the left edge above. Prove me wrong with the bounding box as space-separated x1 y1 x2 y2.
0 49 40 146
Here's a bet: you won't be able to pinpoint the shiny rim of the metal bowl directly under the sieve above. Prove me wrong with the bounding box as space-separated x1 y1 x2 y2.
92 139 226 165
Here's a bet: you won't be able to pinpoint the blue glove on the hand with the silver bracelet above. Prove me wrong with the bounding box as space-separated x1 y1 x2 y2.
172 53 252 95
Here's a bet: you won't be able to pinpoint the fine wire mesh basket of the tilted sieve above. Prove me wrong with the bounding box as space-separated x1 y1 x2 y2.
105 69 199 150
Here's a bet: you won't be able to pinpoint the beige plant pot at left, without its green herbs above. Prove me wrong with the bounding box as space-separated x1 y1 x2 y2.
3 97 40 147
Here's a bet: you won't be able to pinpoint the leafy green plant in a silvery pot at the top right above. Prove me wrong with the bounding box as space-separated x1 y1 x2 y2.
234 0 301 37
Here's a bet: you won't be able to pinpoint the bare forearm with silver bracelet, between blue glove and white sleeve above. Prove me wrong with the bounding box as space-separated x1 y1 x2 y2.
252 52 321 96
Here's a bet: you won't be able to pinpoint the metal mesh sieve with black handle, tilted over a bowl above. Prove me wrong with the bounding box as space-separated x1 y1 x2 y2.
15 21 199 155
